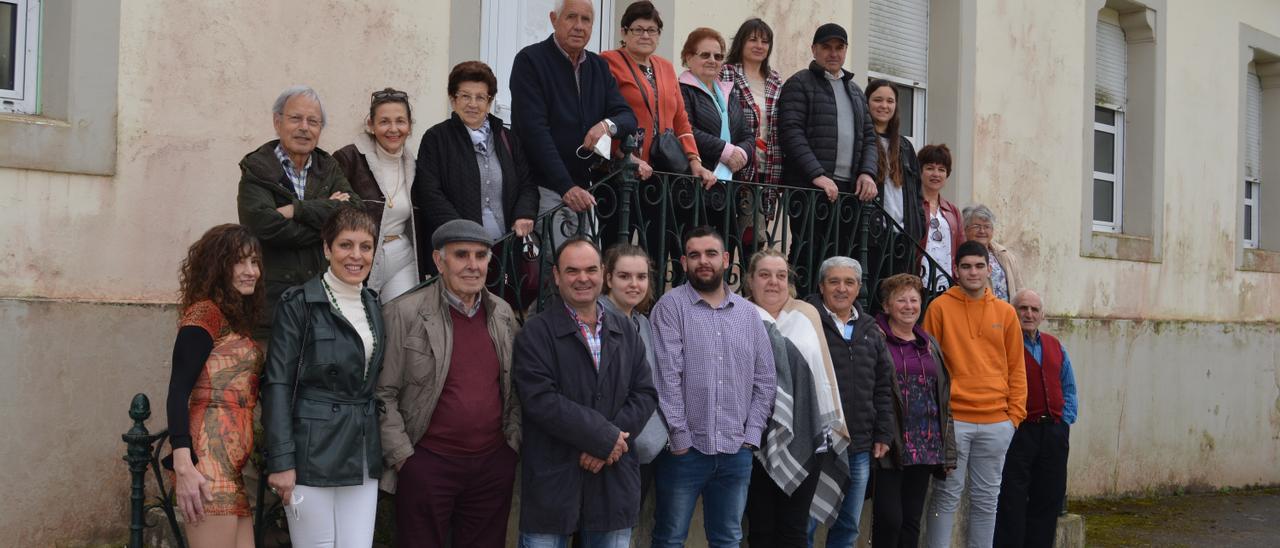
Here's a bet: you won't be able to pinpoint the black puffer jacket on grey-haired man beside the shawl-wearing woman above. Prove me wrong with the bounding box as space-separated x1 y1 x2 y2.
805 293 897 453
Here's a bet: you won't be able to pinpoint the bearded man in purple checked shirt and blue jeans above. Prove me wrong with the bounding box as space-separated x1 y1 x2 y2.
653 227 776 547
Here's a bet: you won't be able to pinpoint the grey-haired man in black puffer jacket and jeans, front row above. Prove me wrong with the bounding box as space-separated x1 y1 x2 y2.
806 256 897 547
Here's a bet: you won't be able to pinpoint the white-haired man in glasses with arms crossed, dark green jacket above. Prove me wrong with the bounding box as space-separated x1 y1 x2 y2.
236 86 362 341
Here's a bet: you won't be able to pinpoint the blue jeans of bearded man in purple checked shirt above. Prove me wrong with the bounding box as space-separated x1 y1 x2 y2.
653 448 751 548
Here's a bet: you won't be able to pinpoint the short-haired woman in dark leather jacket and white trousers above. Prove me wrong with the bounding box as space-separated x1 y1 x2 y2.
262 207 385 547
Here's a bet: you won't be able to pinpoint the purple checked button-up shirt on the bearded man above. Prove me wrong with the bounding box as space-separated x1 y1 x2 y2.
652 284 777 455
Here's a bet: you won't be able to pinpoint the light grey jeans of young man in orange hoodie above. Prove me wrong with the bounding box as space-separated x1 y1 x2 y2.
925 420 1016 548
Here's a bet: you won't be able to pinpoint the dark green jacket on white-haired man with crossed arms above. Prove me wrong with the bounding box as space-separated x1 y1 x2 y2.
236 140 362 335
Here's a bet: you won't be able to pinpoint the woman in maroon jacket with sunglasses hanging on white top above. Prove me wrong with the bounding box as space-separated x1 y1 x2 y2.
918 145 964 286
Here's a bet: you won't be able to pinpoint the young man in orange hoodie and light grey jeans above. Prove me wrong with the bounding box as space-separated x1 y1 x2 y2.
924 241 1027 548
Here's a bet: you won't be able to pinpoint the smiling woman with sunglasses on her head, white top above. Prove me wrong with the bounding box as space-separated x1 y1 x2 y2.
333 87 419 302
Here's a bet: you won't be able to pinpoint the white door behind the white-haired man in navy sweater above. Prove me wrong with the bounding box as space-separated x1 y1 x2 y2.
480 0 617 124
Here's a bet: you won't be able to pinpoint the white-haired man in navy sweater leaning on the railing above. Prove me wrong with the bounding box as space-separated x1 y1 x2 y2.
509 0 636 244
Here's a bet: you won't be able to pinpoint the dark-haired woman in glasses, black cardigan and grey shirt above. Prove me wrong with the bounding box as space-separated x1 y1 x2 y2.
413 61 538 273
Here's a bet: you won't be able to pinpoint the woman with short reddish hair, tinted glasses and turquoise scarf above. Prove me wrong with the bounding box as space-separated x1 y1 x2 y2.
680 27 755 179
